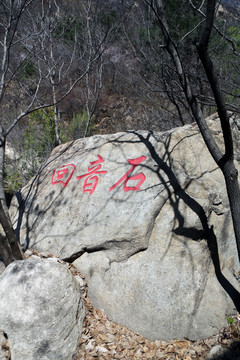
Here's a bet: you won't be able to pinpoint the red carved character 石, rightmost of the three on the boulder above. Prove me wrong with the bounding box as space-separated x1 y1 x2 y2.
109 156 146 191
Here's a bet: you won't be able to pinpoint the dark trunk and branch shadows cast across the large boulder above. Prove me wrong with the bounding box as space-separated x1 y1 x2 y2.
12 131 240 311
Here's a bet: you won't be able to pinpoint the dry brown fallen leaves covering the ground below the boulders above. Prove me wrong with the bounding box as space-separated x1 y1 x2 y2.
70 266 240 360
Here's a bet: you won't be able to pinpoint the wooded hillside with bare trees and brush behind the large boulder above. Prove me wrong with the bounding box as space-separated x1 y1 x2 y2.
0 0 240 193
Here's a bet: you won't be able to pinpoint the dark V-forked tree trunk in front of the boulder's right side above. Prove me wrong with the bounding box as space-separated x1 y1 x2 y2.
144 0 240 259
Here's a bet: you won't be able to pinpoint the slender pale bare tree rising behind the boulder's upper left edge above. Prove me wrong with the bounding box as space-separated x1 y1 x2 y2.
31 3 79 144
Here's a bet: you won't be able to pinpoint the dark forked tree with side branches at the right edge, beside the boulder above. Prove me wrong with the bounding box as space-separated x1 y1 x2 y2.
143 0 240 259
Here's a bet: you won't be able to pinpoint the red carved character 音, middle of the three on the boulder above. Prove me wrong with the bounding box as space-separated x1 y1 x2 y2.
77 155 107 195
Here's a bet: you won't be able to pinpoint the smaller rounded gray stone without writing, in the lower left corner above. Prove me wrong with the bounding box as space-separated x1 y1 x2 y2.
0 259 84 360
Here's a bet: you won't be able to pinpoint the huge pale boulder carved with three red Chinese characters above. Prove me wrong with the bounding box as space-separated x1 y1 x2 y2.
11 118 240 340
